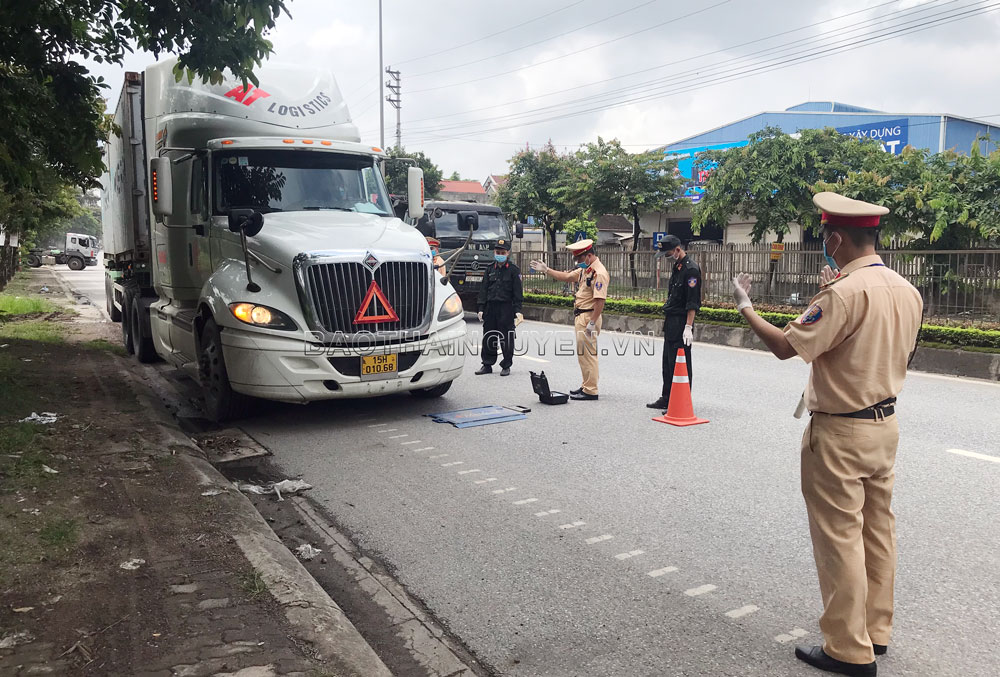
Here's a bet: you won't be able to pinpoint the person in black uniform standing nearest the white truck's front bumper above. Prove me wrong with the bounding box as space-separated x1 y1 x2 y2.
476 240 524 376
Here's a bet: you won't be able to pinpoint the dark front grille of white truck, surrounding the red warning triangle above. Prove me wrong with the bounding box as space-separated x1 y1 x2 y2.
305 261 430 334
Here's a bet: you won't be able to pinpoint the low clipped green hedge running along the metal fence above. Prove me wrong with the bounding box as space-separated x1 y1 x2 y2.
524 293 1000 351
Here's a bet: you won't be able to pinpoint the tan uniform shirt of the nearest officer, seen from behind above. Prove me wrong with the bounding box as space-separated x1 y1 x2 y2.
784 255 923 414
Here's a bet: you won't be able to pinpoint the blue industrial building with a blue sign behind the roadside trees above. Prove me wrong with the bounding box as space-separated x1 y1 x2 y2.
642 101 1000 242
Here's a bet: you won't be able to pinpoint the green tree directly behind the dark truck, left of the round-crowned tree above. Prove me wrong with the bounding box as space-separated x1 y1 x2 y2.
496 143 580 251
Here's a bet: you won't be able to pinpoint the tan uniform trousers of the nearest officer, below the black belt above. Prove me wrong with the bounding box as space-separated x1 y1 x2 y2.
802 413 899 663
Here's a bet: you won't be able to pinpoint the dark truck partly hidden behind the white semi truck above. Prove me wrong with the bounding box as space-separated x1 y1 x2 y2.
415 201 523 309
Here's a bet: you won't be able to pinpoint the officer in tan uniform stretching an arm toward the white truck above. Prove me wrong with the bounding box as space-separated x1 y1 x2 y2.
531 240 611 400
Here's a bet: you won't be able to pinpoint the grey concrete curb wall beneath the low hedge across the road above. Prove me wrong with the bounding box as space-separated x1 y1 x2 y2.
523 305 1000 381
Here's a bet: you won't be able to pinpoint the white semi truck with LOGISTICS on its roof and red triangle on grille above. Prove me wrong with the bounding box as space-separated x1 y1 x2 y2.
102 60 475 420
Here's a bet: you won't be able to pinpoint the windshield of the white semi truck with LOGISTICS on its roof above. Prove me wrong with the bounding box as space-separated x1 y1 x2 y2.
213 150 393 216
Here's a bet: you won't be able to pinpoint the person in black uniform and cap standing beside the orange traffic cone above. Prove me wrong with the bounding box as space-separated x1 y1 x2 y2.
646 235 701 410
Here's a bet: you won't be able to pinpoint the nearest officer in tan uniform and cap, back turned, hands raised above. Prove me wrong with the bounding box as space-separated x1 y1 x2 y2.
733 193 923 677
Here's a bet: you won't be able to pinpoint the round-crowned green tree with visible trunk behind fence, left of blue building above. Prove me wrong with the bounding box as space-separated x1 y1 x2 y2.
556 137 687 287
